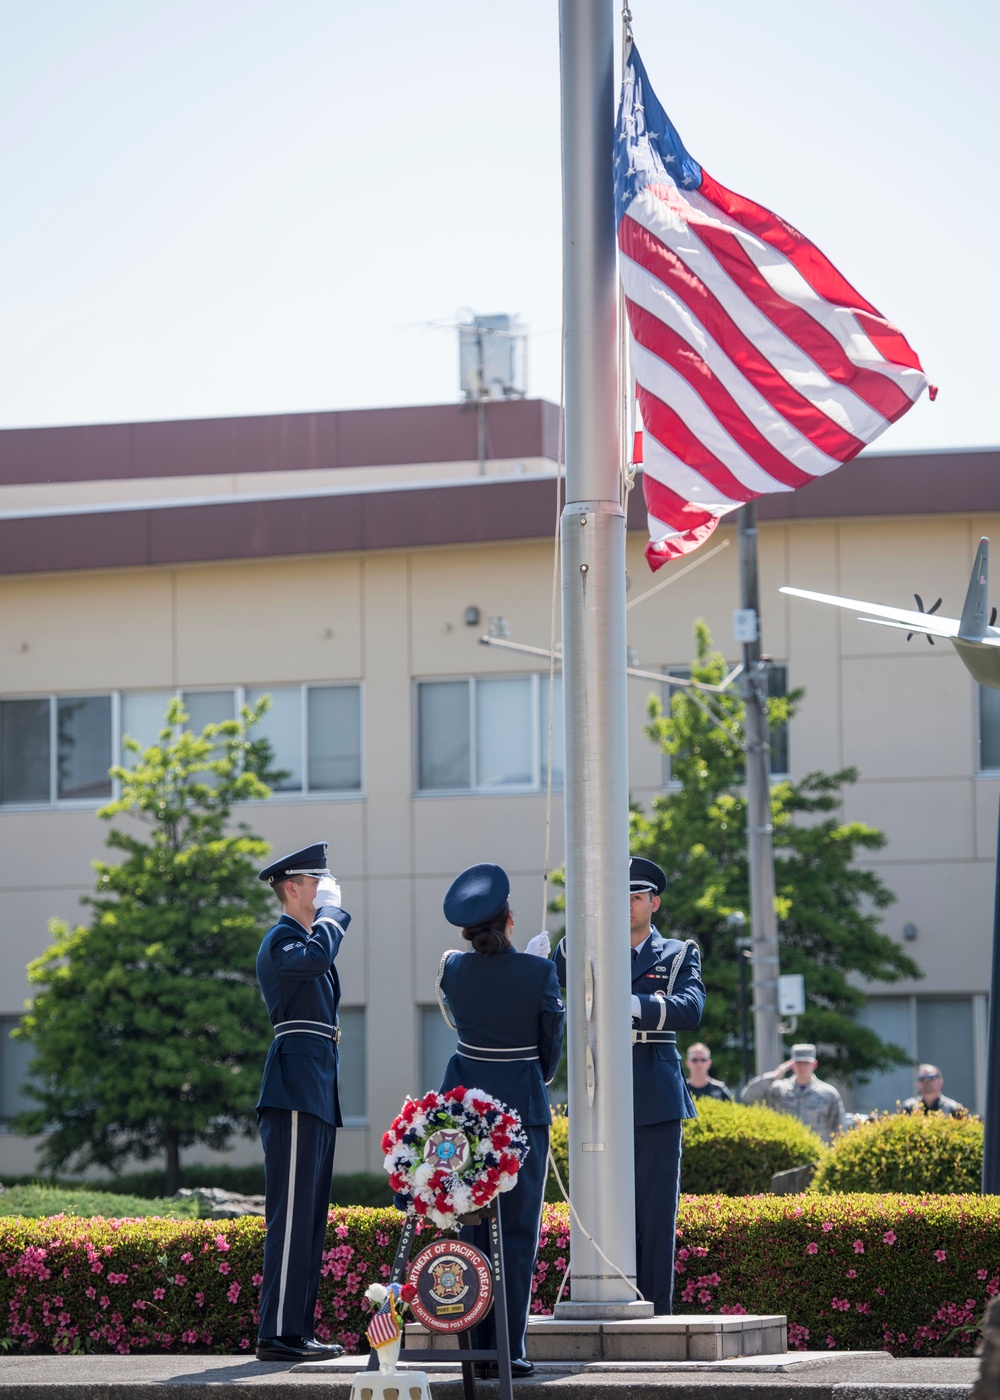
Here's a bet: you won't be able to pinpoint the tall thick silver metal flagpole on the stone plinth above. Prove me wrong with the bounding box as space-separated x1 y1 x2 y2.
556 0 641 1317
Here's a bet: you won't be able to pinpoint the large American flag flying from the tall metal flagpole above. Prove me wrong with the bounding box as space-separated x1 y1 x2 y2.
615 48 936 568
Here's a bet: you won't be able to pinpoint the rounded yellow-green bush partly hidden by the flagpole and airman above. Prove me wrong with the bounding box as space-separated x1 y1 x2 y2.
545 1099 826 1201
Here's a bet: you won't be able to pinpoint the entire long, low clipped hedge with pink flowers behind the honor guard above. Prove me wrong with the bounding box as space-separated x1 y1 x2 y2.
0 1196 1000 1355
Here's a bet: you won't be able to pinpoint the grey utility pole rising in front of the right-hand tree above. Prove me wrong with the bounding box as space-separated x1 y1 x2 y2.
739 503 784 1074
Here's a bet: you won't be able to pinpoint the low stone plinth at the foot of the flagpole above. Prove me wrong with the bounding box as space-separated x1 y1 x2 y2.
406 1313 789 1365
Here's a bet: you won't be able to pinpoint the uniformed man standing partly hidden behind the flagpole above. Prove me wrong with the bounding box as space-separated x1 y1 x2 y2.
555 855 704 1313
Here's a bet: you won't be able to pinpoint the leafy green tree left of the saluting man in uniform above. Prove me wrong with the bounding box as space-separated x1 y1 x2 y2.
15 699 275 1194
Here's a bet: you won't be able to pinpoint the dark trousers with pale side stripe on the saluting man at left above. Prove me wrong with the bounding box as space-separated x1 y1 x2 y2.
258 1109 336 1337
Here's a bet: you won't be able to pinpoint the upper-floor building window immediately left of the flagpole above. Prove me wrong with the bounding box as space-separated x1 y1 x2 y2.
416 675 563 792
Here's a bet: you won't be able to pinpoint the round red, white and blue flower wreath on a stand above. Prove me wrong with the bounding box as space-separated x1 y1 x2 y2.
382 1088 528 1229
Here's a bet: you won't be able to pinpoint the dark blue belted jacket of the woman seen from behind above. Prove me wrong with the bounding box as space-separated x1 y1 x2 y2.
438 948 566 1126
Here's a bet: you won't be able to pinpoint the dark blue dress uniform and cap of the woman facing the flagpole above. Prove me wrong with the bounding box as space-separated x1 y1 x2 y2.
438 865 566 1361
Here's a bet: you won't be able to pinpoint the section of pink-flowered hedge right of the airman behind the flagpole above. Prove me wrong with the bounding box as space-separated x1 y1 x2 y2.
674 1196 1000 1357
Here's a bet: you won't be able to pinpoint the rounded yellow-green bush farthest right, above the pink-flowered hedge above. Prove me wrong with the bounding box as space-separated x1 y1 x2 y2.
811 1113 983 1194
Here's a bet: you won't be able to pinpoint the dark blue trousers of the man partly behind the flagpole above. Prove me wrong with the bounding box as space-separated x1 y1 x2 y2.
636 1119 681 1313
